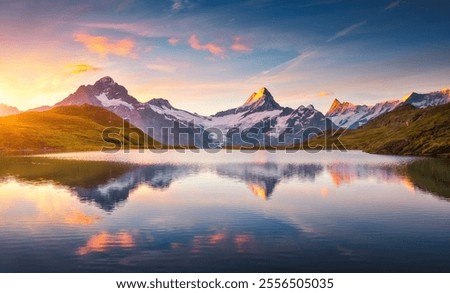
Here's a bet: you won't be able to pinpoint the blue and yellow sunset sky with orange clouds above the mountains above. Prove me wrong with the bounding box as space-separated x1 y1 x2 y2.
0 0 450 115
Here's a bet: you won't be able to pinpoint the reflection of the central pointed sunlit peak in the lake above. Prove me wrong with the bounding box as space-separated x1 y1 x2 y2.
215 163 323 200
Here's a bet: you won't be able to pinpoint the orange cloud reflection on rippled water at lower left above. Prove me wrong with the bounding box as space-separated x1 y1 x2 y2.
77 232 135 255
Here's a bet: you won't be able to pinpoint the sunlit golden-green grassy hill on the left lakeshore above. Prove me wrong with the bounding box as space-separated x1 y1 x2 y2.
0 105 159 155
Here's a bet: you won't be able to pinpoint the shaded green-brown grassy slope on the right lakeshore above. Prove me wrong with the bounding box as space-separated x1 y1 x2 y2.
311 104 450 157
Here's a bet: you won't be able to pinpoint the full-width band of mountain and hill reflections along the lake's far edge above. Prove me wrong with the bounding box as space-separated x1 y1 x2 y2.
0 157 450 212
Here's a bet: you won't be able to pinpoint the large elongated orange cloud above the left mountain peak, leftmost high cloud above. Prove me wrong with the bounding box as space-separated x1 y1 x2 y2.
74 33 135 57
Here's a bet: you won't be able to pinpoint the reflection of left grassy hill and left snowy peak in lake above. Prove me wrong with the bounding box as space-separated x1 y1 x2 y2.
0 157 199 212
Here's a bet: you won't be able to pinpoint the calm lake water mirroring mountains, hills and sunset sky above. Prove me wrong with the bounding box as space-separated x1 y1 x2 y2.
0 151 450 272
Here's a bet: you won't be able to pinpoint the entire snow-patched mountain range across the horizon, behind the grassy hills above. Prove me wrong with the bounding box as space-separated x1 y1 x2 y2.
0 76 450 148
